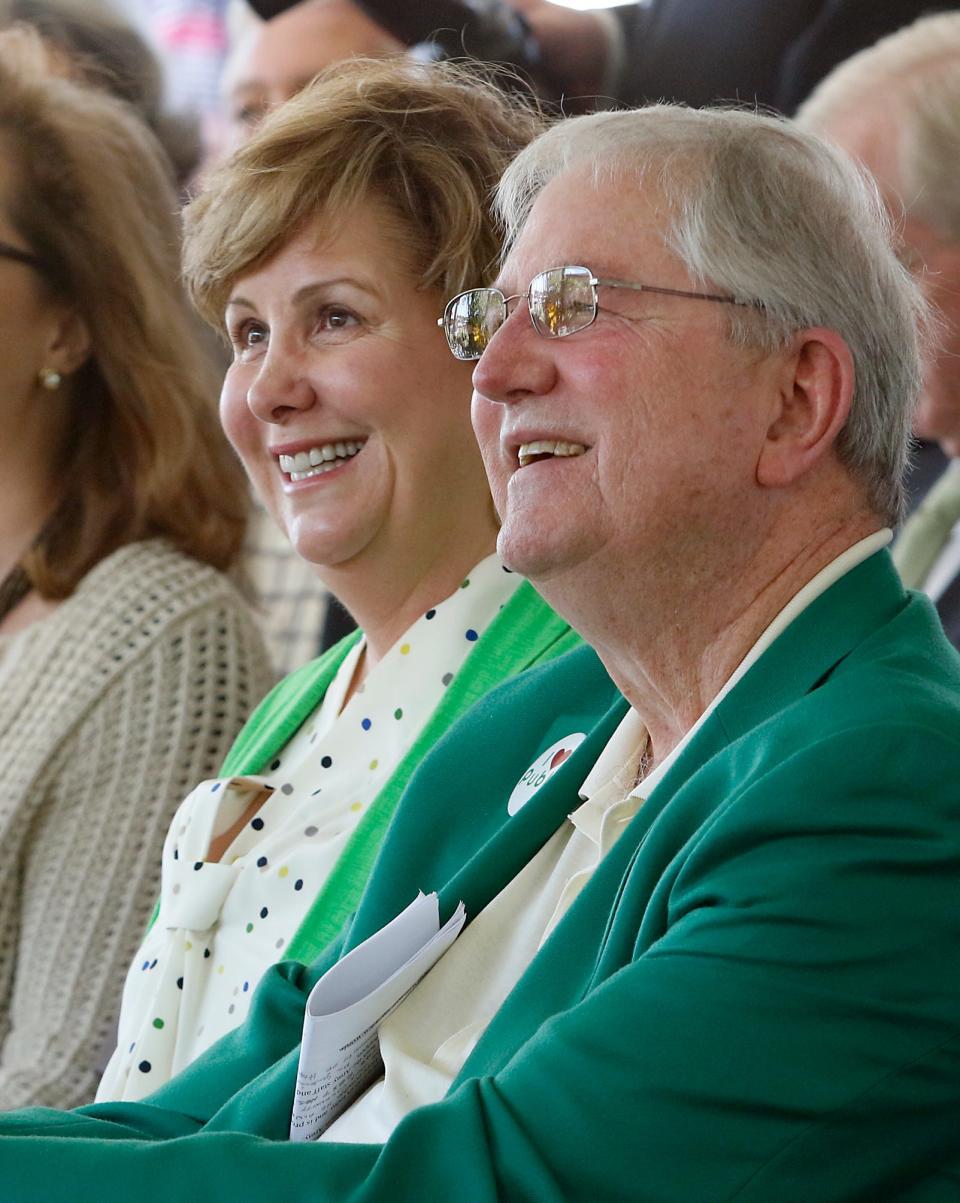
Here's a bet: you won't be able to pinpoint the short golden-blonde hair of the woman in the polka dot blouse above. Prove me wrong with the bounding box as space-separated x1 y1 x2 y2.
184 59 543 326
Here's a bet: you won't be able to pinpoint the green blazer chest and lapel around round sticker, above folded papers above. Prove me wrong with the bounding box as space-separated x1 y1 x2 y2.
346 647 627 948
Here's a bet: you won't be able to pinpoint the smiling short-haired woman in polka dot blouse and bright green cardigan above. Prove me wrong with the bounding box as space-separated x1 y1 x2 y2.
97 60 587 1100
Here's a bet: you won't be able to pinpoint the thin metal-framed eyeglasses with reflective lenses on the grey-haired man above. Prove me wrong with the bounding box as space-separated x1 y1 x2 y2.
437 267 751 360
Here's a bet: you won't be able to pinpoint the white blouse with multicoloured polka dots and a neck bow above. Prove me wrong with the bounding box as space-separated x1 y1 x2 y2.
97 556 521 1102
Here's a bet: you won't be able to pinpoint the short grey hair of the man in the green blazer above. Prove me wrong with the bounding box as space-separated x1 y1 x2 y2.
498 105 929 522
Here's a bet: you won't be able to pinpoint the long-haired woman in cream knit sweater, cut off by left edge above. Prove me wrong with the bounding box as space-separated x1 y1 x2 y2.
0 32 269 1108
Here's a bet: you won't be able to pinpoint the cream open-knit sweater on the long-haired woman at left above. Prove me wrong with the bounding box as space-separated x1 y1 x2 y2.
0 540 272 1109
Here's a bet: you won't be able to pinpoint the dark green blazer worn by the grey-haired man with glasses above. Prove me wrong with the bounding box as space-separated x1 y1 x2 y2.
0 552 960 1203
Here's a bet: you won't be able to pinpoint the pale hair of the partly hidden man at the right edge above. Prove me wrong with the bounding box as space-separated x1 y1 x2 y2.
796 12 960 242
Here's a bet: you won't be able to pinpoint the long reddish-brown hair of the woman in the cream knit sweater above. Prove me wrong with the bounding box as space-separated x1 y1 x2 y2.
0 30 249 598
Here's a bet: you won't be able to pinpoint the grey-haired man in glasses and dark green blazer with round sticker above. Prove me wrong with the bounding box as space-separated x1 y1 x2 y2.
0 107 960 1203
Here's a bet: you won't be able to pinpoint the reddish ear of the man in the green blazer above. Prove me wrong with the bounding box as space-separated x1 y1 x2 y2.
757 327 854 488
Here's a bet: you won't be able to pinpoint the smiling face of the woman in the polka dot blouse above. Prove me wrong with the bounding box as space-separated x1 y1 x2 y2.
221 202 490 567
